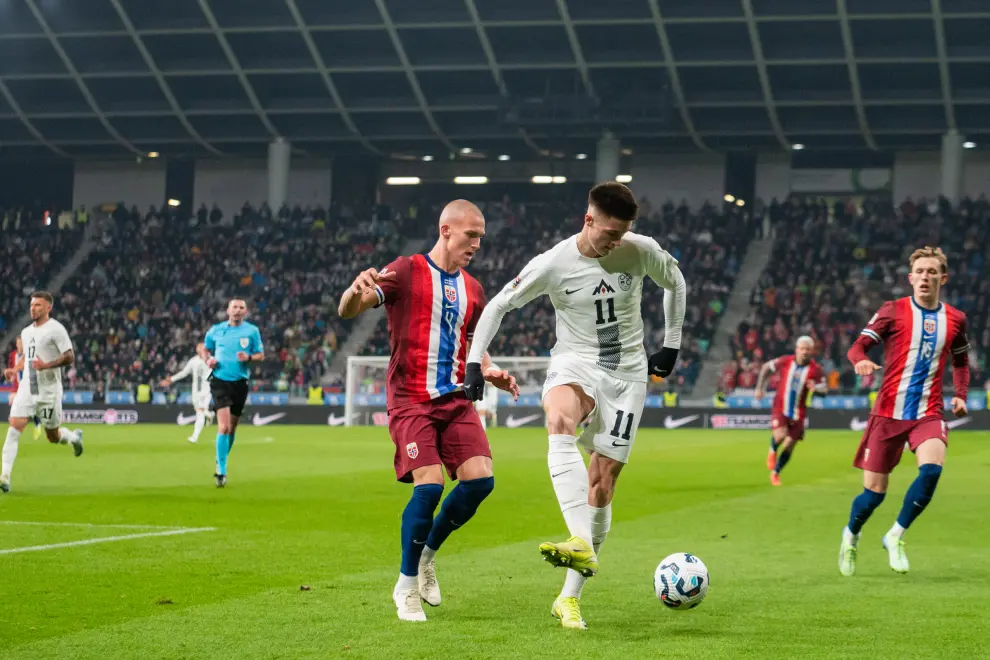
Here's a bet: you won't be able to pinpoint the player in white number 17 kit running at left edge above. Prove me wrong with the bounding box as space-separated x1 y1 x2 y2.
0 291 83 493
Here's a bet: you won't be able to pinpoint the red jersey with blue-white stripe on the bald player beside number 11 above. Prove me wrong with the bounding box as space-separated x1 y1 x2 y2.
378 254 485 410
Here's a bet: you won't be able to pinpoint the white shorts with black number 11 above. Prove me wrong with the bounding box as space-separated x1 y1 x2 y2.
543 358 646 463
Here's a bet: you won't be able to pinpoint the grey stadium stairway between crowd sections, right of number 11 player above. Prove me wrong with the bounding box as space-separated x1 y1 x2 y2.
694 233 774 397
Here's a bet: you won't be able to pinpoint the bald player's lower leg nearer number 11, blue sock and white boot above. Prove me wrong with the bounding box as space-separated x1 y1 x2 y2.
418 456 495 607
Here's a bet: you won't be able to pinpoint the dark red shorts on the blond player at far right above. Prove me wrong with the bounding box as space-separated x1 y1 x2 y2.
853 415 949 474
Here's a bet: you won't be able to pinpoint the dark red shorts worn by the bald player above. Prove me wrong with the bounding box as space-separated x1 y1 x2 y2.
388 392 492 483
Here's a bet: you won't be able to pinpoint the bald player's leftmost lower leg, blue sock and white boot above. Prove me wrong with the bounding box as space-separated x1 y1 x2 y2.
392 465 443 621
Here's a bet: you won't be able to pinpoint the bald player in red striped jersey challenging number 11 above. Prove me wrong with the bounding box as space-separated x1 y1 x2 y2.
337 200 519 621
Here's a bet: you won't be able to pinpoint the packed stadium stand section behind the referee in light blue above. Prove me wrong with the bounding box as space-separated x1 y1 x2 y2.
53 205 401 389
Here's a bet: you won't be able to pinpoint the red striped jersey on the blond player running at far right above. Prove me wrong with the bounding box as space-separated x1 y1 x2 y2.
862 297 969 420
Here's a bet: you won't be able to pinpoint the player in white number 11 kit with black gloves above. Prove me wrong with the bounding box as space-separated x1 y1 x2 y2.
464 182 687 629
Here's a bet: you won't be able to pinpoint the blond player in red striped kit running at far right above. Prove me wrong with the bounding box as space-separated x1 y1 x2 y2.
839 247 969 576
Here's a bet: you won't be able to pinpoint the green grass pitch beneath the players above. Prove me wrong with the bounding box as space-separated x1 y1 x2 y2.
0 426 990 660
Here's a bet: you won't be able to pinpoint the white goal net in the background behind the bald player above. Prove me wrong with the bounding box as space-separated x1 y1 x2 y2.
344 355 550 426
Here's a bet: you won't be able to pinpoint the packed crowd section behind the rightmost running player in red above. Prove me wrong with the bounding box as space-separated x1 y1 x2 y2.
721 197 990 393
